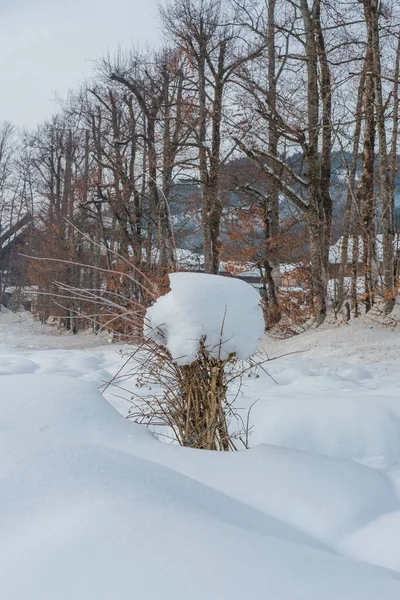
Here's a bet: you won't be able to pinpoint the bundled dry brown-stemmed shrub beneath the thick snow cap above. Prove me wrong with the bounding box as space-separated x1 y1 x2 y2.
107 339 264 451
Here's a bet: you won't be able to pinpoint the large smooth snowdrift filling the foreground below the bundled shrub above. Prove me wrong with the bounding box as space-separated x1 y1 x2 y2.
0 373 400 600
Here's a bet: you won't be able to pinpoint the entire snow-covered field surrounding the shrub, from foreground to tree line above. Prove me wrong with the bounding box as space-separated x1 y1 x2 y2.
0 312 400 600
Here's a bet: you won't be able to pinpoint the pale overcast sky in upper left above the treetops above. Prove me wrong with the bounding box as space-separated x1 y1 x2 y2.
0 0 160 128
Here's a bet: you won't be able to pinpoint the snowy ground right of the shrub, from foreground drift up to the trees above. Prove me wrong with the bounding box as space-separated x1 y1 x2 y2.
242 317 400 467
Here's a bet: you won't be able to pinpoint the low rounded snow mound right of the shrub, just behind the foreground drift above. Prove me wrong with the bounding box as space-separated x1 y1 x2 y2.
252 392 400 468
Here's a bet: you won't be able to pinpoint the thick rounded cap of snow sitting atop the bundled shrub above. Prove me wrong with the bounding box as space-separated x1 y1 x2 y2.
145 273 264 364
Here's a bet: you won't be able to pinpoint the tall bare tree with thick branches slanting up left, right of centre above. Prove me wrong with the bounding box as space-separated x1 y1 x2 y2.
237 0 332 324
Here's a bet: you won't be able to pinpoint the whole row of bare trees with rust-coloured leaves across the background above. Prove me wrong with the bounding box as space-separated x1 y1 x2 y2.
0 0 400 333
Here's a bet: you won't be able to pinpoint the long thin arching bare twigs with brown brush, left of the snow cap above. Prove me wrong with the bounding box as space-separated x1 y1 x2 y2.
26 221 168 343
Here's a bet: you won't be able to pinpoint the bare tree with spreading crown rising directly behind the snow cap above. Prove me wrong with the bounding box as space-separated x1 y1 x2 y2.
161 0 260 273
